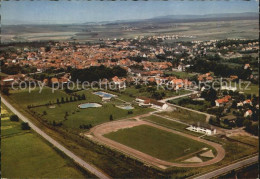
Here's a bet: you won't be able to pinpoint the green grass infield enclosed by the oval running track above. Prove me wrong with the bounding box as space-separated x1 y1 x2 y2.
104 125 208 162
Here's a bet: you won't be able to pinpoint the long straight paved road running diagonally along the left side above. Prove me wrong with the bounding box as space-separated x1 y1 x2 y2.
1 97 109 179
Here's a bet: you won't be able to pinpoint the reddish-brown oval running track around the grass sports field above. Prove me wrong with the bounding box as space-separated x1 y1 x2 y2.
85 120 225 169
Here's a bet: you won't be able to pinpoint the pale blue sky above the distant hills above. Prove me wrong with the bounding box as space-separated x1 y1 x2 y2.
1 0 259 25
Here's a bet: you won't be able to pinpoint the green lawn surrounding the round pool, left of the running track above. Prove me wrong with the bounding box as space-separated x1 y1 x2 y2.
32 91 153 129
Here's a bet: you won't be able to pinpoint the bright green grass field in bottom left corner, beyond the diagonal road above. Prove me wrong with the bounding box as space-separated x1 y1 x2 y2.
1 106 93 178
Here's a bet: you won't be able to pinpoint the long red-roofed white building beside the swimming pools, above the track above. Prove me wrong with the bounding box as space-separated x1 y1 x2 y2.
135 97 168 110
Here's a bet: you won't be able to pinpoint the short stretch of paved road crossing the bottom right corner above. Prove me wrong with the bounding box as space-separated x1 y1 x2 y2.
195 155 258 179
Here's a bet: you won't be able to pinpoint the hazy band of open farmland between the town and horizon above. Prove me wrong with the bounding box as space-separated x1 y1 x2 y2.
2 19 258 43
